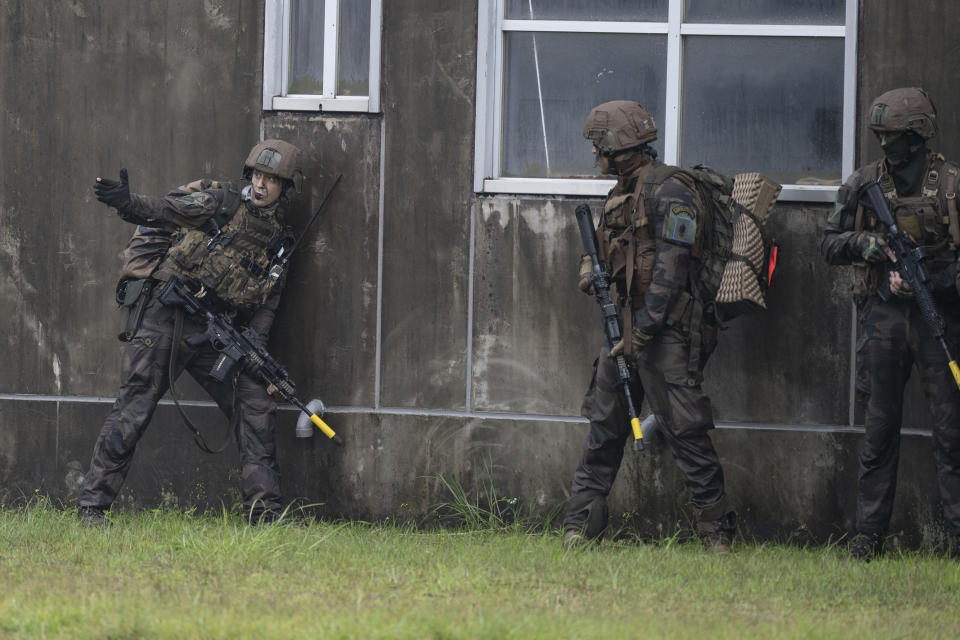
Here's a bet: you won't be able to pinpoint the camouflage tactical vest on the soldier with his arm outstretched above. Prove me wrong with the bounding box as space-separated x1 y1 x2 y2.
159 202 292 309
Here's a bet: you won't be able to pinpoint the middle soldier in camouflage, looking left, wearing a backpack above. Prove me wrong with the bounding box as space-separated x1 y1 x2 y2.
564 100 736 551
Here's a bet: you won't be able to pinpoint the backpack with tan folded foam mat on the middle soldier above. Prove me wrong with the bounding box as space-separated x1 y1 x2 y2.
643 164 780 320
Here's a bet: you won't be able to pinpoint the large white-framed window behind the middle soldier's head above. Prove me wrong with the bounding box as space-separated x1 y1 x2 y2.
474 0 857 202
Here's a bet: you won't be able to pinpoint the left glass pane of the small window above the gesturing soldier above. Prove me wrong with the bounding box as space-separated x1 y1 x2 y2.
287 0 325 94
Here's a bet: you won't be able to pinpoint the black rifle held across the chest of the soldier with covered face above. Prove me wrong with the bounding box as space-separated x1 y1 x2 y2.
859 180 960 387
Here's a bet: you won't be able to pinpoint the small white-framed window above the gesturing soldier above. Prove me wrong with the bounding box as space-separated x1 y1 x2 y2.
263 0 382 112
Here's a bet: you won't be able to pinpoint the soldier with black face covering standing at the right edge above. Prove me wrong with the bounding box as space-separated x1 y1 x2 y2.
821 88 960 559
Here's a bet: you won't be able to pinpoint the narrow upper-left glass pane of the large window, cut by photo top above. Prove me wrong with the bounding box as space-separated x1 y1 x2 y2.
507 0 668 22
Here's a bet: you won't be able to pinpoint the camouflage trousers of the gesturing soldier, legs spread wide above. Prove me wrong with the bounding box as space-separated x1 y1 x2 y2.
77 287 282 515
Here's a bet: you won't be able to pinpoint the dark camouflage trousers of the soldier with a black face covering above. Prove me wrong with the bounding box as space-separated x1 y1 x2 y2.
857 296 960 535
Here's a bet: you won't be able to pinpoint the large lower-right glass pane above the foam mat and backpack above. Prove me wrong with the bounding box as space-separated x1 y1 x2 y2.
680 36 843 184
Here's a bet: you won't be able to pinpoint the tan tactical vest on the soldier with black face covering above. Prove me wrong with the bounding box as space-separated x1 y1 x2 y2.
853 154 960 297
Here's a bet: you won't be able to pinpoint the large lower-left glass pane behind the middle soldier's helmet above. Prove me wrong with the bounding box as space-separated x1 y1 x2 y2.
500 32 667 178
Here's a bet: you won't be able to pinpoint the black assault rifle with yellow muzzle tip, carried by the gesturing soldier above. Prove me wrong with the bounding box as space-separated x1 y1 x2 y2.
160 278 343 446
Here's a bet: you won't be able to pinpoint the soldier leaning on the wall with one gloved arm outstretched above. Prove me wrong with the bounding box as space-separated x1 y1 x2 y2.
77 140 303 525
